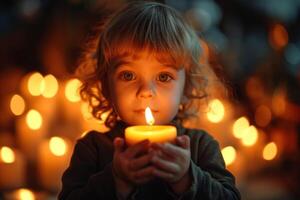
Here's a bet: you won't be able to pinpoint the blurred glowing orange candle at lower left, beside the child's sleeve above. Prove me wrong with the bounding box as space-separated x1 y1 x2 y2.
38 137 71 192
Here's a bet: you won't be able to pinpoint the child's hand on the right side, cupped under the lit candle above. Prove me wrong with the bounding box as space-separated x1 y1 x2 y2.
151 135 191 193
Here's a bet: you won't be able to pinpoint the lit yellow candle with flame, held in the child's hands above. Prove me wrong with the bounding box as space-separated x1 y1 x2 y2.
125 107 177 146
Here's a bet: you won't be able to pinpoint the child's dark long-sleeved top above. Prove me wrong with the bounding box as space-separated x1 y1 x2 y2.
59 122 240 200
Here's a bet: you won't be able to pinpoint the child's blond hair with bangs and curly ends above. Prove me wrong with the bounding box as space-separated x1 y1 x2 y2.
77 2 213 128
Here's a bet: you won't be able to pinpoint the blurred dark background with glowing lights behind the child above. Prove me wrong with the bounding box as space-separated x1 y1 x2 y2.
0 0 300 200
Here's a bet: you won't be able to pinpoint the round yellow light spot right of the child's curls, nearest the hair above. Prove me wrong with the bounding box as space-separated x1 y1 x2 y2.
206 99 225 123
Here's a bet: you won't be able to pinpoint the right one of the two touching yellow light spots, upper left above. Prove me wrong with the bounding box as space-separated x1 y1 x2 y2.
41 74 58 98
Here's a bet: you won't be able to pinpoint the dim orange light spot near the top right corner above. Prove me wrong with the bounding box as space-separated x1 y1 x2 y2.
269 24 289 49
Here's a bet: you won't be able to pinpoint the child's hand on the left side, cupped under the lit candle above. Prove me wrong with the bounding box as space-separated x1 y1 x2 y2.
113 138 154 185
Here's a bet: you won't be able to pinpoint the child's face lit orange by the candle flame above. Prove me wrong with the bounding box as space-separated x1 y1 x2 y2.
110 54 185 125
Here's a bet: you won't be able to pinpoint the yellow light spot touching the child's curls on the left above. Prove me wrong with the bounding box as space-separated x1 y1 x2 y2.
65 79 82 102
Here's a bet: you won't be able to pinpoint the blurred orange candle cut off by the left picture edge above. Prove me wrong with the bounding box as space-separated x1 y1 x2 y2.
0 146 25 190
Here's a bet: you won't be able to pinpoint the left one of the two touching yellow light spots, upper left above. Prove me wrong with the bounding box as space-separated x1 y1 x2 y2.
27 72 44 96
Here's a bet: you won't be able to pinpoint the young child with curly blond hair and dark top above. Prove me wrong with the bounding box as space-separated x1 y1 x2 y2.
59 2 240 200
